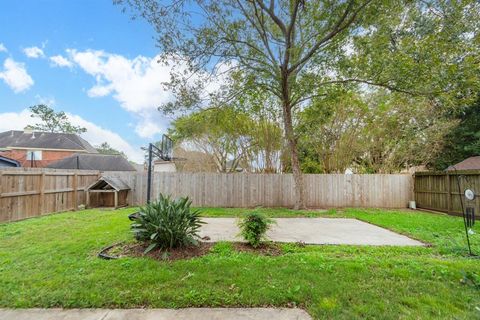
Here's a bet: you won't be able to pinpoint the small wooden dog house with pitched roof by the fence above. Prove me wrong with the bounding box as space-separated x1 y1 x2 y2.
85 177 131 209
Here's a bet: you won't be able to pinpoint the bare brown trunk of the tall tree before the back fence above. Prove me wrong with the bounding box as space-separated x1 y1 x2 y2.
283 101 307 210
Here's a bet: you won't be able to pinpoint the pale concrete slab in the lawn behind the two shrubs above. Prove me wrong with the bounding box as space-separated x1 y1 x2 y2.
200 218 424 246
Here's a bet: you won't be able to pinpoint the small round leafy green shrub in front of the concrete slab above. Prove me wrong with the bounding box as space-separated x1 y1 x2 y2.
238 212 273 248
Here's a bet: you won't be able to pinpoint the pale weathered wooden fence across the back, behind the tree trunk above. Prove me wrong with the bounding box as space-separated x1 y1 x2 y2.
135 173 413 208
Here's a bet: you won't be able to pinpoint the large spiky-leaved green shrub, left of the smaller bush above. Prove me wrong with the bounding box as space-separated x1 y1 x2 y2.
132 194 203 253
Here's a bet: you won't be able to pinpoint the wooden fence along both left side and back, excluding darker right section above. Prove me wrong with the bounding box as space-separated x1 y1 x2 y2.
0 169 413 221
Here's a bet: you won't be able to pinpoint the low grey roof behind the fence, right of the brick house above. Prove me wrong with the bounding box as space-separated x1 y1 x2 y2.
47 153 136 171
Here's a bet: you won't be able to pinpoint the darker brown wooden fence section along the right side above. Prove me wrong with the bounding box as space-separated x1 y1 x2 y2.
414 170 480 215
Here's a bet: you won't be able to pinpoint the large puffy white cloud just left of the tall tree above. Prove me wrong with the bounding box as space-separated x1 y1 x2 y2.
67 49 173 138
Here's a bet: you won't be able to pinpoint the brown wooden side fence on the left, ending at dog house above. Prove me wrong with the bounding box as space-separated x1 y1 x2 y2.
0 168 99 222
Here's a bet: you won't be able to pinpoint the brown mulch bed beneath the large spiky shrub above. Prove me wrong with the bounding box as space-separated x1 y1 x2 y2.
102 242 214 261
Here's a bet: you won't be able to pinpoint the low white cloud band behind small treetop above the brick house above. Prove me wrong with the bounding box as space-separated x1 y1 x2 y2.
0 109 143 163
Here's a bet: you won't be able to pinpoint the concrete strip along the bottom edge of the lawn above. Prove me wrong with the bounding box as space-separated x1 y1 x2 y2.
0 308 312 320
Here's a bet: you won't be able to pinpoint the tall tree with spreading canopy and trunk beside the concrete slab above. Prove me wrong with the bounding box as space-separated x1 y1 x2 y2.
114 0 480 208
